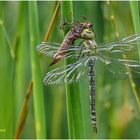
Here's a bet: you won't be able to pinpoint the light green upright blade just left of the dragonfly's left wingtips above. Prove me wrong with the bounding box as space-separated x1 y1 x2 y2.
28 2 46 139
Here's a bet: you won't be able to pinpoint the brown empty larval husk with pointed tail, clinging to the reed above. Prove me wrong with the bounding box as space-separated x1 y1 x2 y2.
50 22 92 65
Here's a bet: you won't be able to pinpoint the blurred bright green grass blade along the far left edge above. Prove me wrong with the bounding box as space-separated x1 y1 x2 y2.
0 6 14 139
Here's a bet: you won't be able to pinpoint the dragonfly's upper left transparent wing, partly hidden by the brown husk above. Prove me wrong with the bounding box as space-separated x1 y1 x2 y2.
36 42 82 59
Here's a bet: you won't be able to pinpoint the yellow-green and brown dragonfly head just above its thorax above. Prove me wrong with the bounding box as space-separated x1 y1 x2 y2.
81 22 95 39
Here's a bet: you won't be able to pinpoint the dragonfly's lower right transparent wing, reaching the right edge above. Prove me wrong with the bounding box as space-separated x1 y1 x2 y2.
98 56 140 79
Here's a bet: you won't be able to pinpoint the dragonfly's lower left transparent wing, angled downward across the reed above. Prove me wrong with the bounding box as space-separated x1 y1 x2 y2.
43 57 90 85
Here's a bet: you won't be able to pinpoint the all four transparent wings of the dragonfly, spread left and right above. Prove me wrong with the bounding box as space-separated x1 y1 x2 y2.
37 34 140 85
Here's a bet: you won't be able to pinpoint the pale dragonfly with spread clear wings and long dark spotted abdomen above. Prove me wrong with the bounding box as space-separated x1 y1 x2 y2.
37 21 140 132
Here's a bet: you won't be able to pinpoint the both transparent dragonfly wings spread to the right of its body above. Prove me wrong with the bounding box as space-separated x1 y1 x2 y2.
97 34 140 79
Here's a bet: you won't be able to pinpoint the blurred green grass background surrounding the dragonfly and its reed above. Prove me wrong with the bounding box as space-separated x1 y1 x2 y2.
0 1 140 139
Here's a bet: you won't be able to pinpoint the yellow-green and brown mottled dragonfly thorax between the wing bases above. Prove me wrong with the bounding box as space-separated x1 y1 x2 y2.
82 40 97 56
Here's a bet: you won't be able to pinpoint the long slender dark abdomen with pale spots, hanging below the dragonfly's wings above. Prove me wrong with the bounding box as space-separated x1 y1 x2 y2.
89 60 97 133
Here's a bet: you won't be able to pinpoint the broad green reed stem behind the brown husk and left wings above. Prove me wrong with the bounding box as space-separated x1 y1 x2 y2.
61 1 84 138
